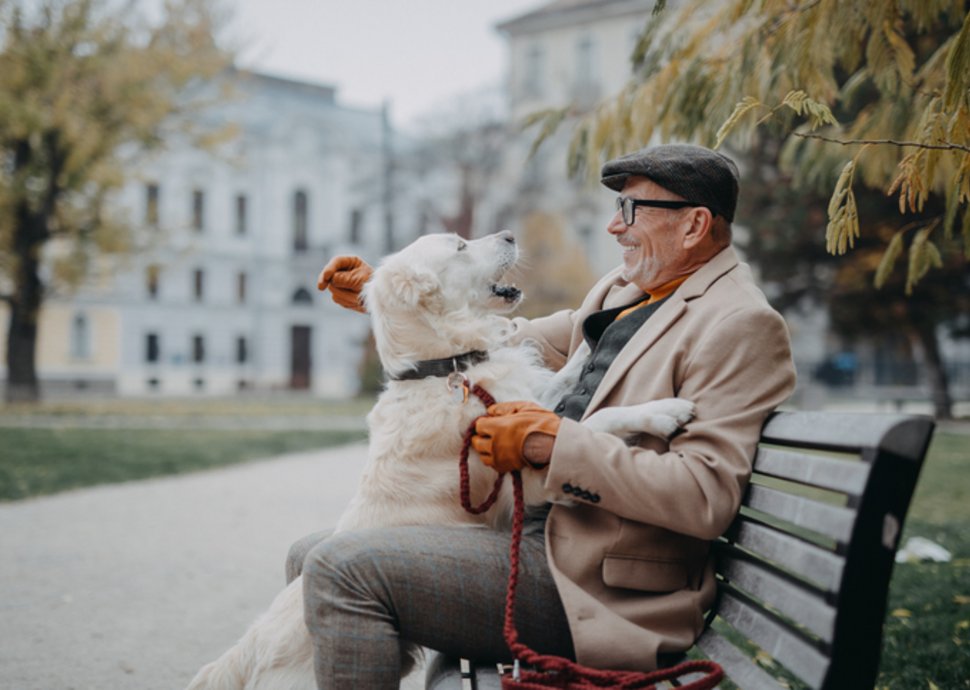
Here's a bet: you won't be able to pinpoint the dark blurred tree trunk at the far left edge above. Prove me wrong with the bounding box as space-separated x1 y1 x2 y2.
6 205 45 402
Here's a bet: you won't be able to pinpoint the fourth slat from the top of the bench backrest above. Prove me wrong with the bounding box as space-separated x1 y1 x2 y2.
727 517 845 592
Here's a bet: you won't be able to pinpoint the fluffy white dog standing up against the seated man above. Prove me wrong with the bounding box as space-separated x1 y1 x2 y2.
189 232 693 690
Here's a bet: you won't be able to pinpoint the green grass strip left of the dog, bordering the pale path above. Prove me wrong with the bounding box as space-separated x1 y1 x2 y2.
0 428 365 501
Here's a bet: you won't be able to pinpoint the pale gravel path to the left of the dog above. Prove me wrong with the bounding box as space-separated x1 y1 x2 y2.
0 445 421 690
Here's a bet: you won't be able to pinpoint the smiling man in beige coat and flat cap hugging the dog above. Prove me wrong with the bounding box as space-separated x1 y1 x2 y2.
290 145 795 688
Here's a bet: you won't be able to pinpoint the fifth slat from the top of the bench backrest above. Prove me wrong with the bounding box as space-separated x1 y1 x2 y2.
718 547 835 642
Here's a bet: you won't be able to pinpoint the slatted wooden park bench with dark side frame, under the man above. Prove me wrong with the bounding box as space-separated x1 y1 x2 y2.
426 412 934 690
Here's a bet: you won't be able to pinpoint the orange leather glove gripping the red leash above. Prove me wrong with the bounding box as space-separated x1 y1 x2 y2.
472 401 562 474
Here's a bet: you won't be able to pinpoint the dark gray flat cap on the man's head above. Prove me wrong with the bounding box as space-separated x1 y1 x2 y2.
600 144 738 222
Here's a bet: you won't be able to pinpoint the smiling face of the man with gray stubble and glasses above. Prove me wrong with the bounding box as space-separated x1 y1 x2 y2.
607 177 692 292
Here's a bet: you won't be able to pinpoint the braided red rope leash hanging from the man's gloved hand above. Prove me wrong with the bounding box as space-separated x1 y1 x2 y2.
458 384 724 690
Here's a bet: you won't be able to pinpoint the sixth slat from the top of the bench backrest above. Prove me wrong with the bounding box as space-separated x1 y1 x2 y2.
717 586 829 688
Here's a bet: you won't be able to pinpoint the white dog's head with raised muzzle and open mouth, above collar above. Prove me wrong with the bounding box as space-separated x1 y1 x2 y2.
364 231 522 373
